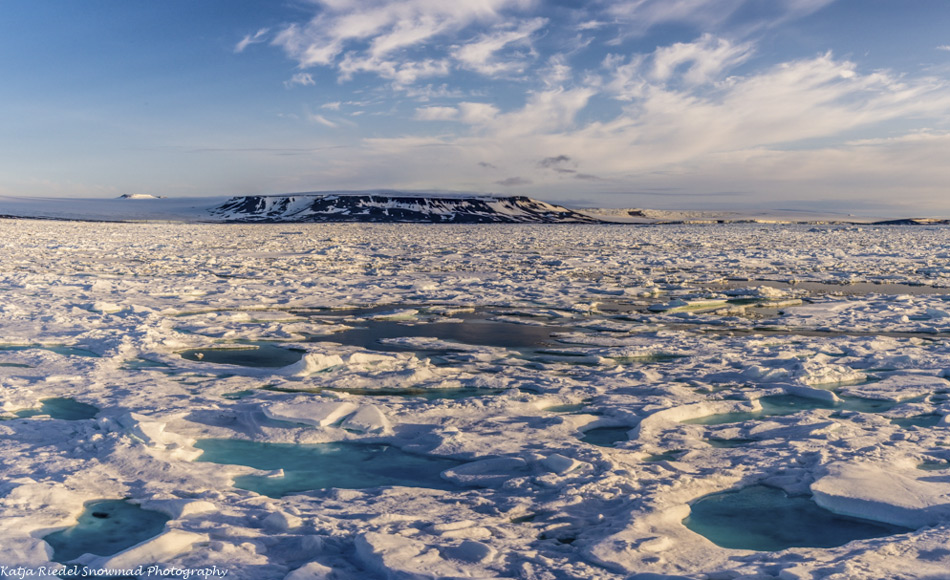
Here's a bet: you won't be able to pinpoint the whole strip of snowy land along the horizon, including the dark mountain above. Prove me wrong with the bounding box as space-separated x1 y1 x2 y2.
0 190 950 226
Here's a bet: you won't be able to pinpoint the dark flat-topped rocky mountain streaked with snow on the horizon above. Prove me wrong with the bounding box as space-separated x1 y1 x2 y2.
211 194 600 223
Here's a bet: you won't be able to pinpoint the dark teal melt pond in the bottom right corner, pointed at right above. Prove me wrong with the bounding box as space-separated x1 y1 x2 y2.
683 485 910 551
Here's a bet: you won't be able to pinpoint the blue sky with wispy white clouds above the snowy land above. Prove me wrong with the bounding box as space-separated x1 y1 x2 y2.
0 0 950 216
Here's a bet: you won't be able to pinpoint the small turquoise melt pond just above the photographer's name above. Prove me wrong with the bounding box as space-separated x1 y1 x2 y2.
43 500 170 563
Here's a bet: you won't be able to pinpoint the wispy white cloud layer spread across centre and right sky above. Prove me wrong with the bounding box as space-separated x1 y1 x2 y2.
235 0 950 213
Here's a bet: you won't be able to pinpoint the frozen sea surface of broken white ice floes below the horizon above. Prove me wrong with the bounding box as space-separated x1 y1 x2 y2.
0 220 950 580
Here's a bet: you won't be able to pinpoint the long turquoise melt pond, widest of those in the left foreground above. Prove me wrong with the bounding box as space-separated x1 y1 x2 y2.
195 439 461 498
